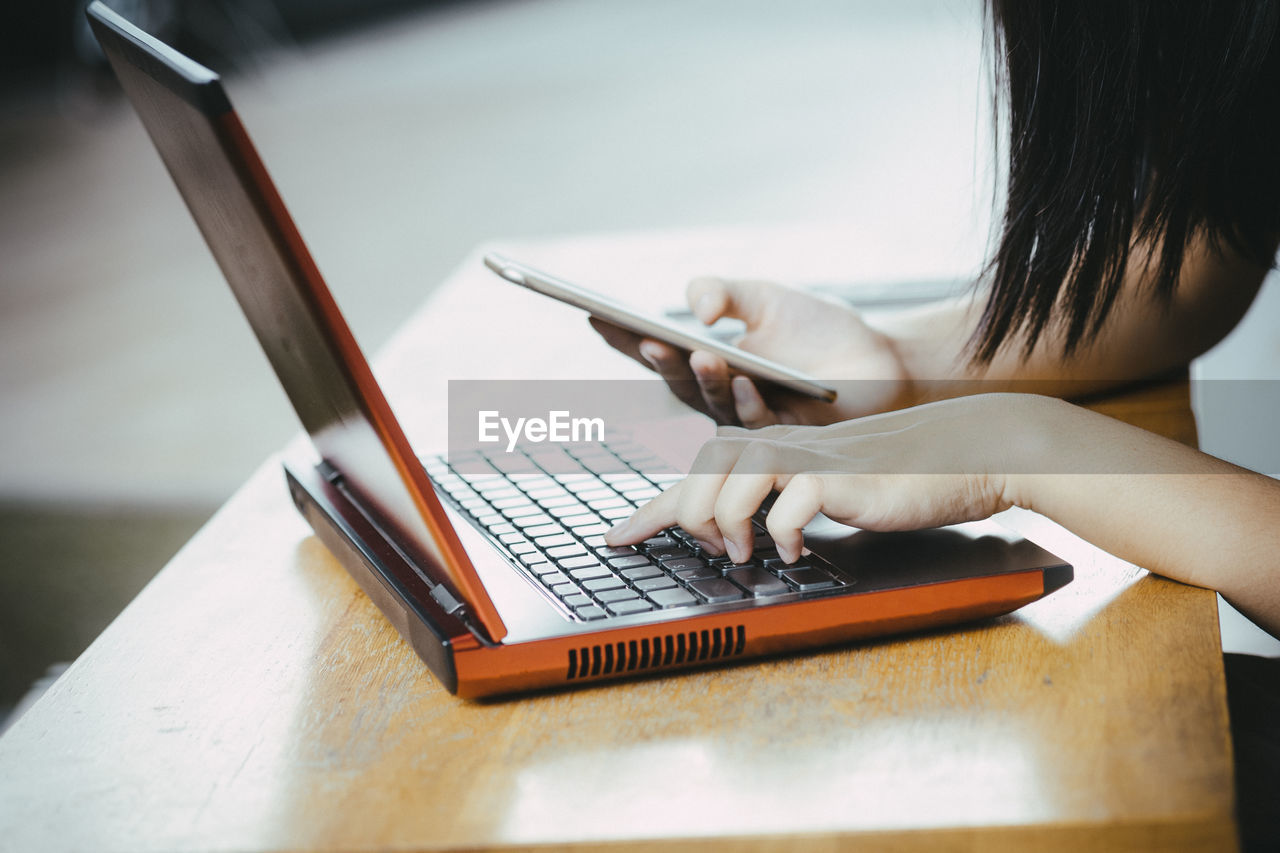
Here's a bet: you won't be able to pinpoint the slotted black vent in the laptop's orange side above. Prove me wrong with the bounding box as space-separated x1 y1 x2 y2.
568 625 746 681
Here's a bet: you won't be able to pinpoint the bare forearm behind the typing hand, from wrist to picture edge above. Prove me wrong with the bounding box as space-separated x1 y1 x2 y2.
1004 398 1280 637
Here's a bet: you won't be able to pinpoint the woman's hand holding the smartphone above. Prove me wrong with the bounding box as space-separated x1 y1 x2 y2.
591 278 911 429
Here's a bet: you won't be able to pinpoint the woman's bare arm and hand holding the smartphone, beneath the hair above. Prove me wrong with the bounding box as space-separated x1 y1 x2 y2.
596 234 1266 427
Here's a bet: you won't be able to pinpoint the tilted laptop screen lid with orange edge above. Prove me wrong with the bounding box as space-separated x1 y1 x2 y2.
88 1 507 640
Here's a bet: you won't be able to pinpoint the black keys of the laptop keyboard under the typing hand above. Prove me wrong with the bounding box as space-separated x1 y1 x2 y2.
424 443 847 621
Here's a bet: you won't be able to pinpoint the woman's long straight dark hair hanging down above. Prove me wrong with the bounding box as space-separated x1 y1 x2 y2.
970 0 1280 364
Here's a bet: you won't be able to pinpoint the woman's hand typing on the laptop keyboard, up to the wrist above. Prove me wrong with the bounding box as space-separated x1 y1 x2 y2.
605 394 1049 562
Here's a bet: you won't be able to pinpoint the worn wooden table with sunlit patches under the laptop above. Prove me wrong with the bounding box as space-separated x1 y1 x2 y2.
0 232 1235 850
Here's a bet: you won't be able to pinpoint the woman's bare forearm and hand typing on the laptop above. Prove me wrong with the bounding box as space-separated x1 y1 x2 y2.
607 394 1280 637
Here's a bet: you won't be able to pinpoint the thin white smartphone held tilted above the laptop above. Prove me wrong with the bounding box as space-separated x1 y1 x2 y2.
484 252 836 402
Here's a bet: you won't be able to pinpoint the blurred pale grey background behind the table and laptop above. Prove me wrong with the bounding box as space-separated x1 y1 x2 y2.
0 0 1280 720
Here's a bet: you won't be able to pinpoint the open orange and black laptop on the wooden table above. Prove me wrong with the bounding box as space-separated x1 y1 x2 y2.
88 3 1073 698
